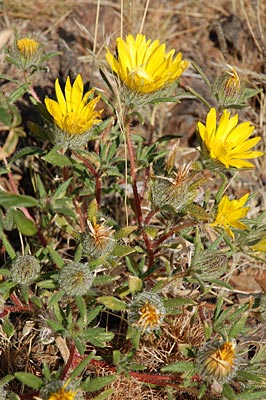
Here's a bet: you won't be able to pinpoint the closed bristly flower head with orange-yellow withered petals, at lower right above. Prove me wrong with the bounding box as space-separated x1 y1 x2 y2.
198 340 237 383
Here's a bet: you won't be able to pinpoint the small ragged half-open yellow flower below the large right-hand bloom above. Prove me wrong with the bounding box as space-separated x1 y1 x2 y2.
211 193 249 239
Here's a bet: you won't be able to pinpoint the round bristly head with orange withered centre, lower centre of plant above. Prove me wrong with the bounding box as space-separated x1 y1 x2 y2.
129 292 165 332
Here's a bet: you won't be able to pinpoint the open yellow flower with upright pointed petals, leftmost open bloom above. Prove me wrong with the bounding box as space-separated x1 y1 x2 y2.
45 74 103 135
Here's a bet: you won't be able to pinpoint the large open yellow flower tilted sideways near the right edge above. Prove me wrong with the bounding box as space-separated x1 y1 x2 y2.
198 108 263 168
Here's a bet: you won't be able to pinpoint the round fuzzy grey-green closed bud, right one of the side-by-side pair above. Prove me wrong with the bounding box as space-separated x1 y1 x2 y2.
58 262 94 296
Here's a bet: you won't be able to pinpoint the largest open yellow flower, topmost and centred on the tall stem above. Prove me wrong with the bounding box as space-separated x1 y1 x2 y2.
106 33 189 94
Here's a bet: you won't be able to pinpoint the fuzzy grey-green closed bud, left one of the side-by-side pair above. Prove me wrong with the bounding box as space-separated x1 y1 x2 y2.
11 255 41 285
